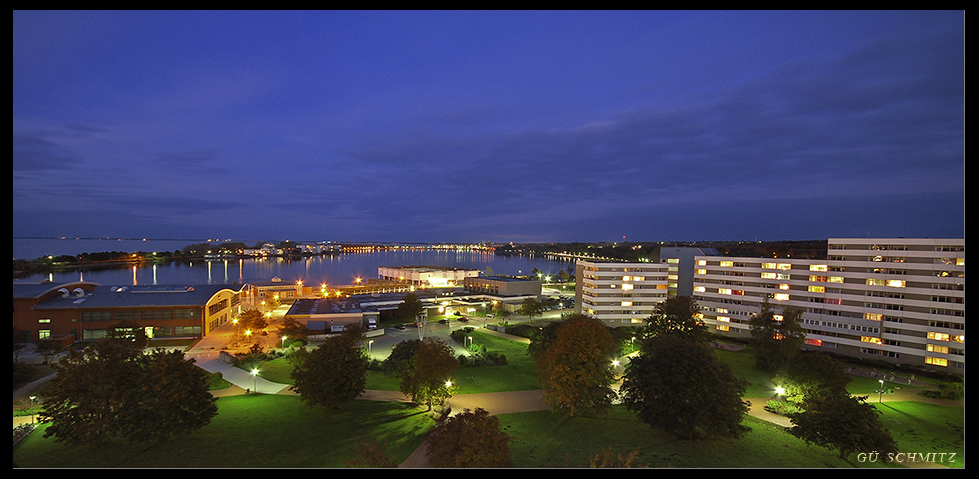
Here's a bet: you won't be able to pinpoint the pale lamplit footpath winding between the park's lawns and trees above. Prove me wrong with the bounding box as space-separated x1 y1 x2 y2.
14 329 962 468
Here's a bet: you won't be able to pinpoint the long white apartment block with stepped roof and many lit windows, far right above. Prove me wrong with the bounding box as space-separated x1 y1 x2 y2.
693 238 965 374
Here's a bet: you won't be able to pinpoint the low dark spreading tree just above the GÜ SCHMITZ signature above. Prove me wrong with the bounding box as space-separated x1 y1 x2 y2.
789 394 897 459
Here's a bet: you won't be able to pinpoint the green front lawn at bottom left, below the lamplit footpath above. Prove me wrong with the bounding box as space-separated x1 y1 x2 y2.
13 394 432 468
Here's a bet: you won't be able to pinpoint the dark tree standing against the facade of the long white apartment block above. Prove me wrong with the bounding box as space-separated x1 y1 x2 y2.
748 298 806 373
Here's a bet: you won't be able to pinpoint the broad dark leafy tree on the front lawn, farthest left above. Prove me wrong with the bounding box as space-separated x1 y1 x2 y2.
40 339 217 446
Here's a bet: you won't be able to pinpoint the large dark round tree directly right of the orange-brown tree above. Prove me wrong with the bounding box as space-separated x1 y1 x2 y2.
621 334 749 439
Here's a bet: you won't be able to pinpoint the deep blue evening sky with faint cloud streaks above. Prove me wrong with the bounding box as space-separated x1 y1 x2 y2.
13 11 965 242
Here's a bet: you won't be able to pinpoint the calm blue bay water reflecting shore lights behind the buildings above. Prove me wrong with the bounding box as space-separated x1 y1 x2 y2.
15 240 574 286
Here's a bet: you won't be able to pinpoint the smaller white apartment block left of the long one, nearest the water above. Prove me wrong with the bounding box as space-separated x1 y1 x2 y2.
575 261 668 326
